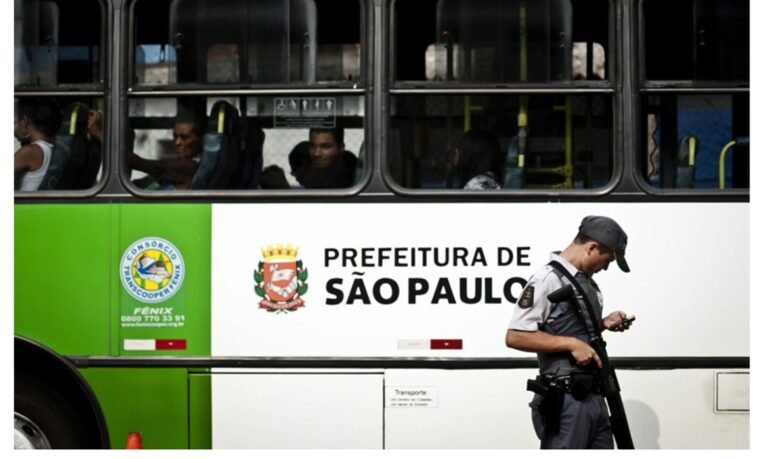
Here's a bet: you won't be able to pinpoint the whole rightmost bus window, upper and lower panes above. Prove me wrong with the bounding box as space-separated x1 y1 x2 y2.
636 0 750 190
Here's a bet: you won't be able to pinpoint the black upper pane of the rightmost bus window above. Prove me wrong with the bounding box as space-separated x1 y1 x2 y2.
643 0 749 81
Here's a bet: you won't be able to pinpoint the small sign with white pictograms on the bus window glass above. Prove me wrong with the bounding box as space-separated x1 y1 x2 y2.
274 97 336 128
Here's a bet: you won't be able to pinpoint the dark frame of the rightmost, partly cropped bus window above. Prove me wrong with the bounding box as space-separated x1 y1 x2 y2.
630 0 750 200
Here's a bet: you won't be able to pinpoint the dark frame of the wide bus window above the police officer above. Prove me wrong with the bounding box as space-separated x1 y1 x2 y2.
381 0 626 200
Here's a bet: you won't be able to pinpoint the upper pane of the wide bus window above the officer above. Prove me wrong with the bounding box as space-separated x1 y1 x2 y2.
395 0 609 83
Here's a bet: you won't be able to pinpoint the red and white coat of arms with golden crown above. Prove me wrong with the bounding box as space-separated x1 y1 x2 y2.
253 244 309 312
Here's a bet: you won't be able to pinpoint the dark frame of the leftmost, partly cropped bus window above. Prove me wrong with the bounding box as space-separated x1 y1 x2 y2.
13 0 114 202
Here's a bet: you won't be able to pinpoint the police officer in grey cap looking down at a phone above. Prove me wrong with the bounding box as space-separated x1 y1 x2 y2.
506 216 629 449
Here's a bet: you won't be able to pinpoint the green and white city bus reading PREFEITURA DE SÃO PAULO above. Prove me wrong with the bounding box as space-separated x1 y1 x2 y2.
13 0 750 449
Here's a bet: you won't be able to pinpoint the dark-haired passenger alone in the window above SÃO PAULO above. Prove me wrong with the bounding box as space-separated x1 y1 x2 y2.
453 129 504 190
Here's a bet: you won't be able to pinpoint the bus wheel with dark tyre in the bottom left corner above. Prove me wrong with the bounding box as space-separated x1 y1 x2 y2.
14 374 89 449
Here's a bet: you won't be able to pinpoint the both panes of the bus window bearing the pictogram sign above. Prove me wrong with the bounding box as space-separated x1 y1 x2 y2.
127 0 365 191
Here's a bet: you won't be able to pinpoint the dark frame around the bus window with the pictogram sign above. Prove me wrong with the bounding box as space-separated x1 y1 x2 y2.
123 0 376 201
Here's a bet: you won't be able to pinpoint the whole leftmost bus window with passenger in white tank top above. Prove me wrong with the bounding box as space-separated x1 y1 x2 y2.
14 0 106 192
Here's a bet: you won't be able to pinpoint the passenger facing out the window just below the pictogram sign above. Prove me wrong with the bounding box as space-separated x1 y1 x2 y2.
305 127 357 188
